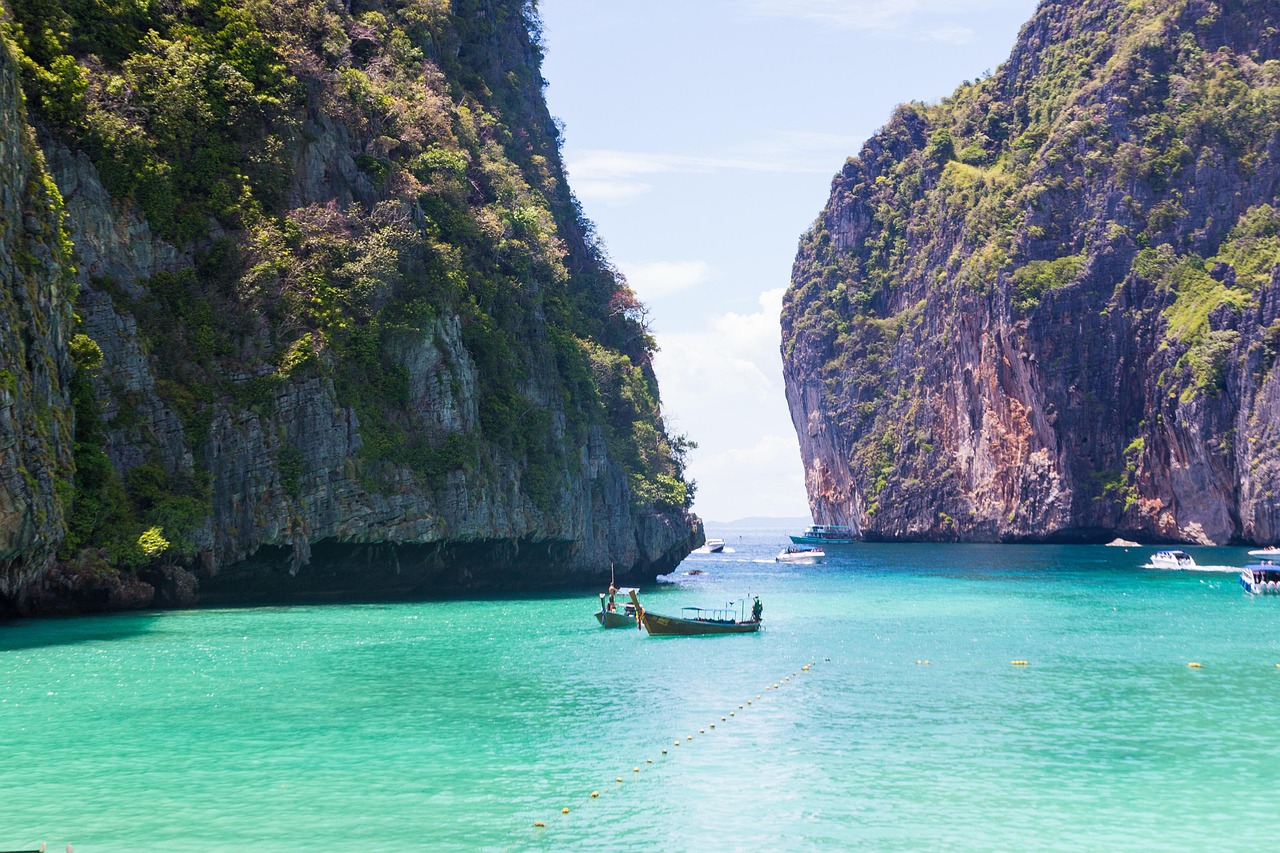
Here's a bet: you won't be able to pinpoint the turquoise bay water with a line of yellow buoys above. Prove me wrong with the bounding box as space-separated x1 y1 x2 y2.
0 530 1280 853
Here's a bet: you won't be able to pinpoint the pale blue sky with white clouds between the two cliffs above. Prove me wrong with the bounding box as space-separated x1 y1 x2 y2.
539 0 1036 522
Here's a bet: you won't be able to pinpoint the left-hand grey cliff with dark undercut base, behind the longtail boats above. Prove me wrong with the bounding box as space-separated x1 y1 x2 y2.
0 1 703 612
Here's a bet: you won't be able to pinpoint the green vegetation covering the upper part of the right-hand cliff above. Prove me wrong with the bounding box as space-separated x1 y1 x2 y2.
783 0 1280 525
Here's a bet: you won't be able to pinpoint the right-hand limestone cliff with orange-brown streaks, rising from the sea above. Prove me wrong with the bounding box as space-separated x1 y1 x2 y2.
782 0 1280 543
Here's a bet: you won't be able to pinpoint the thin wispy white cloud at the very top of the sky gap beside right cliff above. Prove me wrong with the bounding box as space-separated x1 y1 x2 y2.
745 0 1027 44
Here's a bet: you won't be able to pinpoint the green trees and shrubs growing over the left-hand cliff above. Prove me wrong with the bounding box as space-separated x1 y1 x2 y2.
0 0 692 584
